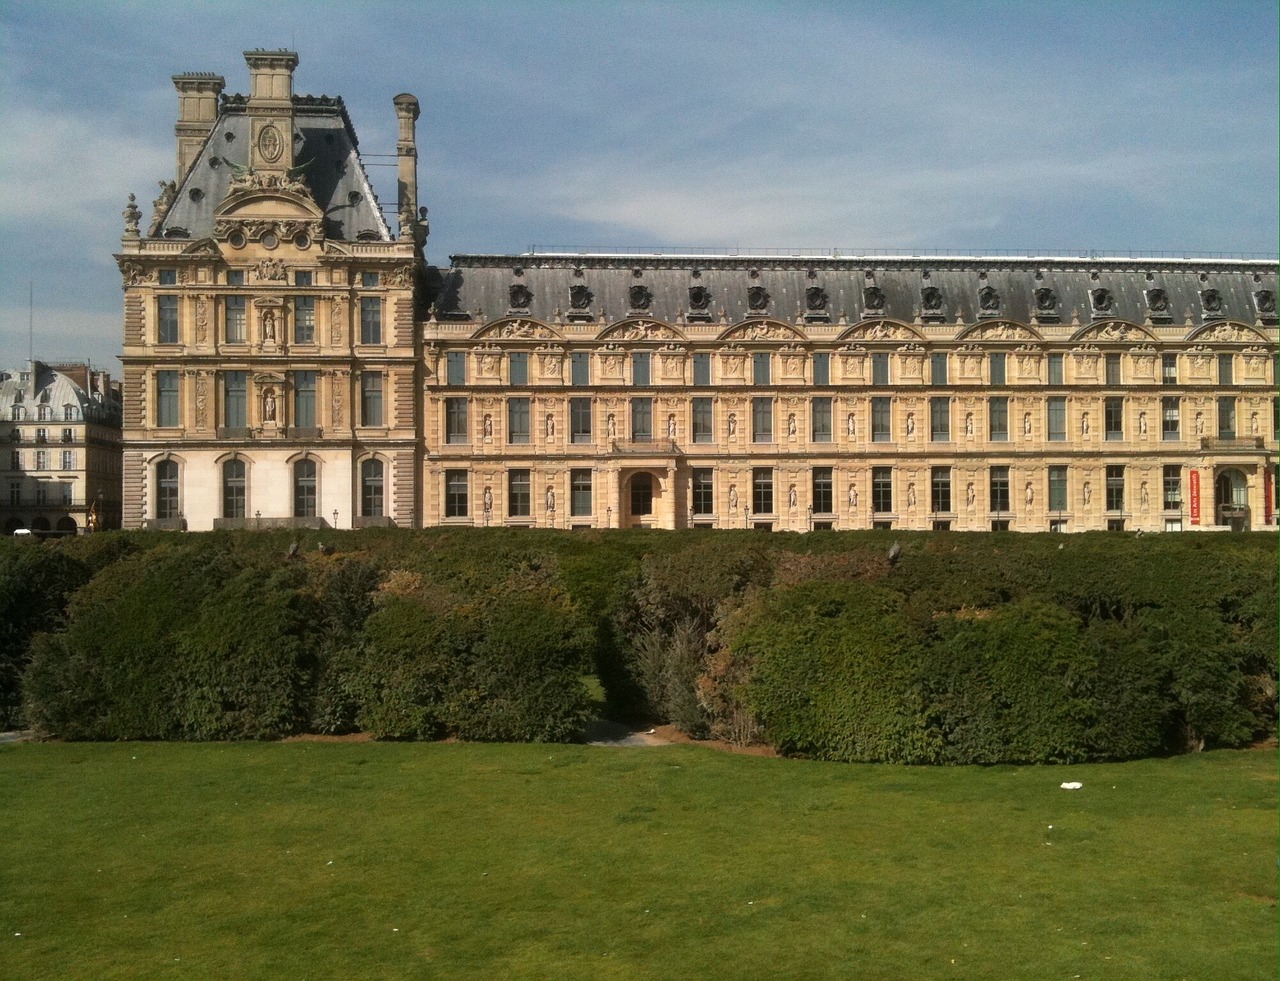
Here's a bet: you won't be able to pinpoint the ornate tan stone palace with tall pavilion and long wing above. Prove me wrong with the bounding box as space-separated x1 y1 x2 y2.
118 51 1280 531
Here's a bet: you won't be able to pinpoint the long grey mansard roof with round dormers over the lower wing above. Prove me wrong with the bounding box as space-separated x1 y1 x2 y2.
434 254 1277 338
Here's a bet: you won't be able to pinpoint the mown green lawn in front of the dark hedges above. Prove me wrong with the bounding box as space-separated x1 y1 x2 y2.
0 743 1277 981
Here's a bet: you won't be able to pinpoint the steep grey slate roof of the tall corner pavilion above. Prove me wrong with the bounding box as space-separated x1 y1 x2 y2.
159 96 392 242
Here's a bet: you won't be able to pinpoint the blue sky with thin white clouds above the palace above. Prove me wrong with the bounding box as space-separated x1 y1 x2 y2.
0 0 1280 375
